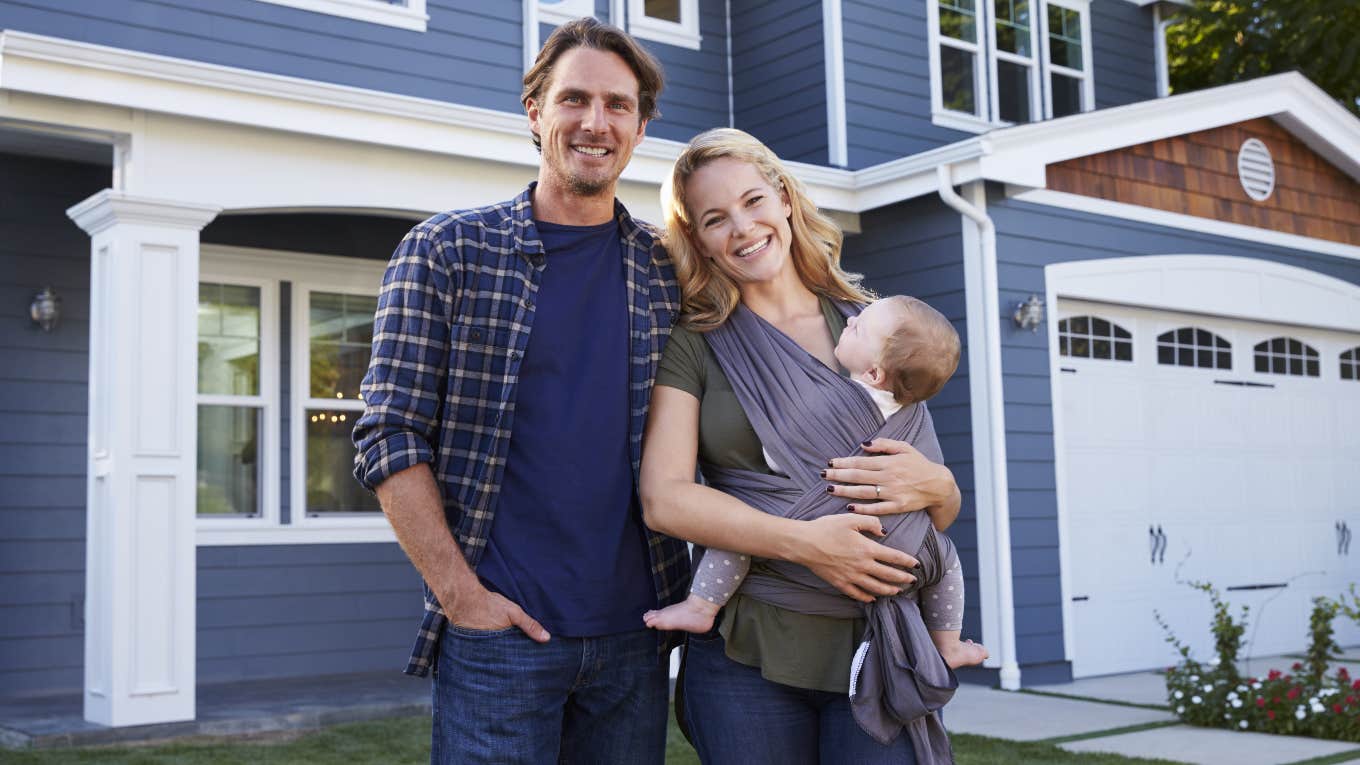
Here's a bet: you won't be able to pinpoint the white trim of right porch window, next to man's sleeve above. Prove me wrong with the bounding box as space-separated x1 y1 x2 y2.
288 271 389 530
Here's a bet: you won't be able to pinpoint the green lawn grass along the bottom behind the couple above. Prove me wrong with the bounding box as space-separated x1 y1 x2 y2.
0 717 1185 765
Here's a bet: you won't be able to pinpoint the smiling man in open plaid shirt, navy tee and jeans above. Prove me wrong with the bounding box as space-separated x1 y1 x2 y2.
354 19 690 764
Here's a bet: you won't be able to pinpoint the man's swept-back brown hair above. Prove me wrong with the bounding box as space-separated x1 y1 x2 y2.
520 16 665 151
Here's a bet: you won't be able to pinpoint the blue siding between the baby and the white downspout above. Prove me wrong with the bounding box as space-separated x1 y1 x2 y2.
843 196 982 638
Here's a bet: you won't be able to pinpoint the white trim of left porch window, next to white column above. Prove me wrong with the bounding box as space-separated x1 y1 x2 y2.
194 276 280 531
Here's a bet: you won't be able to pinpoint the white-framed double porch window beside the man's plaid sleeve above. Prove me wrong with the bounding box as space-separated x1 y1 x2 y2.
197 245 392 544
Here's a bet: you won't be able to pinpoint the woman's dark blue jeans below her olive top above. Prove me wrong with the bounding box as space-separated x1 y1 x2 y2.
684 630 917 765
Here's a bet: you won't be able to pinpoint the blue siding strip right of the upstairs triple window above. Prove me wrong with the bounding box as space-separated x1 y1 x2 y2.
1091 1 1157 109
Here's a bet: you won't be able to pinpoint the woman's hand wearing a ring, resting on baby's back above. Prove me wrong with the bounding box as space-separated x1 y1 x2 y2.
823 438 960 531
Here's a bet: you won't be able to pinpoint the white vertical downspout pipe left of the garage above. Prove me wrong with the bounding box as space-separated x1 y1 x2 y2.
936 165 1020 690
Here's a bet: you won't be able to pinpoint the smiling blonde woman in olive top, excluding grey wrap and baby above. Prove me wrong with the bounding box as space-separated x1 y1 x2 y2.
642 128 959 765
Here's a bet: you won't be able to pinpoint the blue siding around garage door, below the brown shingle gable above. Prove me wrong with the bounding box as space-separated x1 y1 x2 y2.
989 191 1360 666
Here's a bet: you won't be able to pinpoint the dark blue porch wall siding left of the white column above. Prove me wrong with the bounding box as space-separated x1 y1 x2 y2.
0 147 110 696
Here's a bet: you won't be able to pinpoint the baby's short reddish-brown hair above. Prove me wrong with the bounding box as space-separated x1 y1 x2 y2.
879 295 960 406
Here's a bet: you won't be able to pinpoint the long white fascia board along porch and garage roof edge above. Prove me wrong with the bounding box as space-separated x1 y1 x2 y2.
0 30 1360 212
